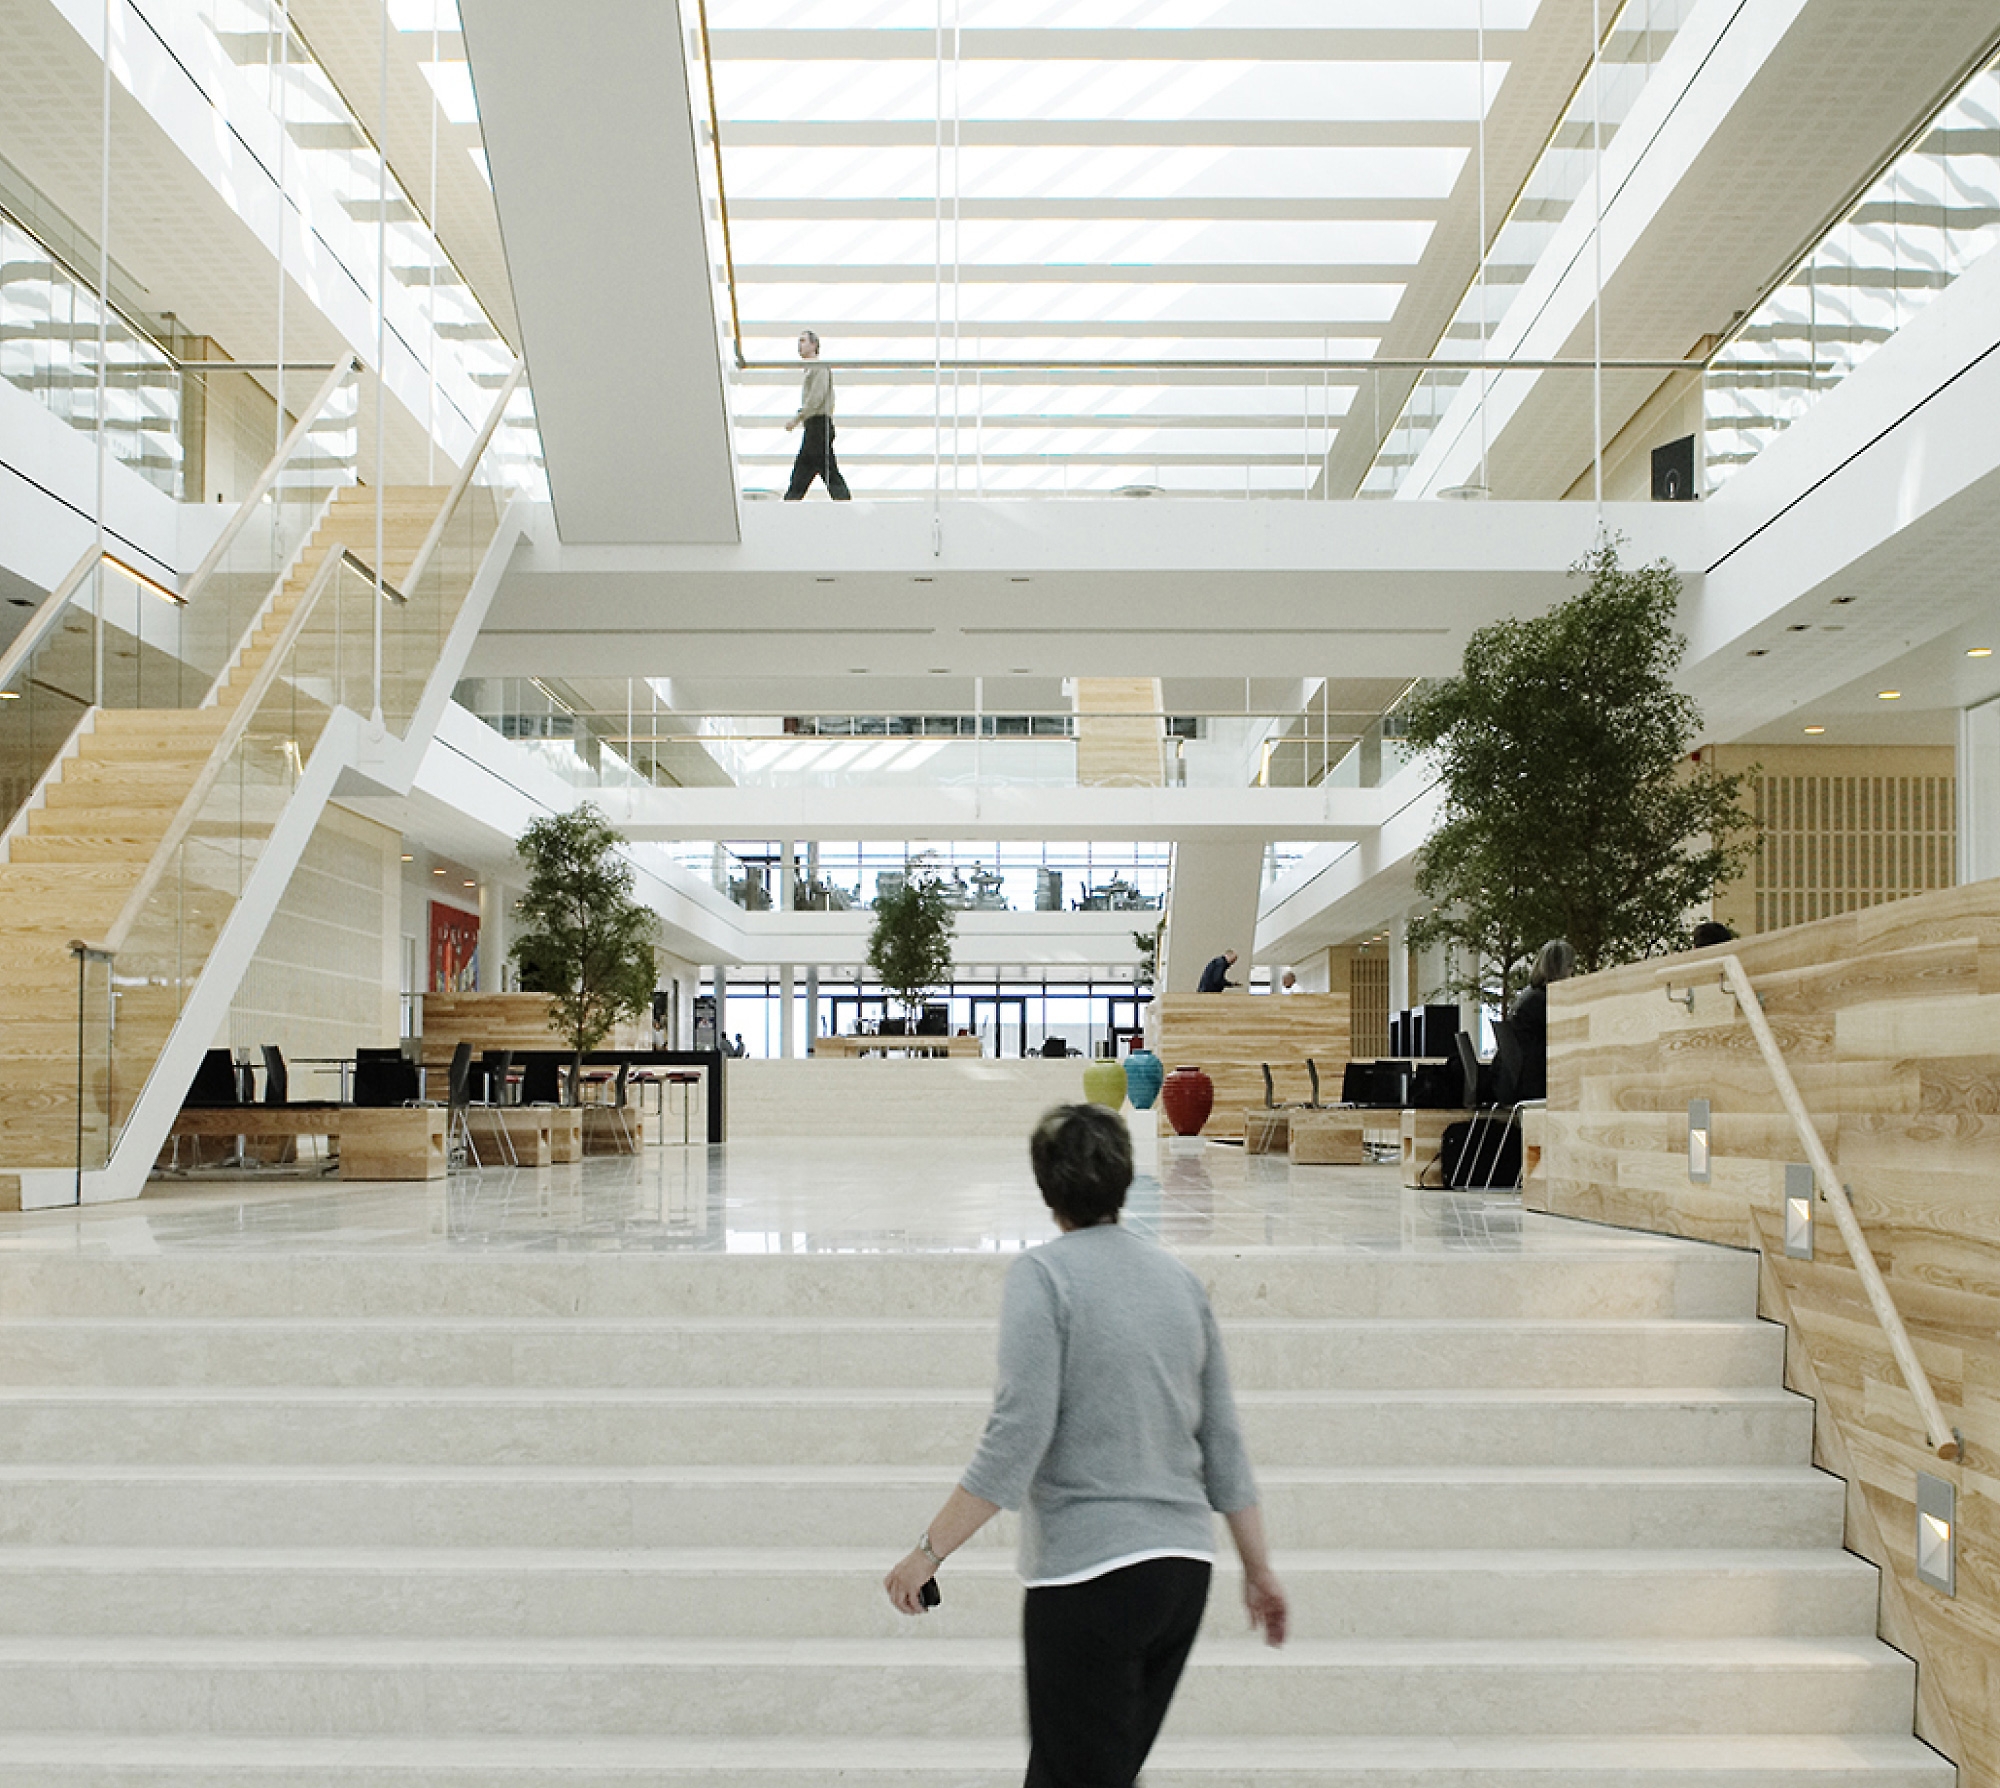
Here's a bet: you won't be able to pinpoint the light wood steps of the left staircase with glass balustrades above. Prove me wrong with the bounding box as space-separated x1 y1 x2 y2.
0 486 498 1206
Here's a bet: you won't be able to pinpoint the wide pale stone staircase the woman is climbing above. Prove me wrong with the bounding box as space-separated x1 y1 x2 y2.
0 1244 1952 1788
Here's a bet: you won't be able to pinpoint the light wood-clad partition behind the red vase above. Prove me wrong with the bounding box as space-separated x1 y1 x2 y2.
1148 994 1348 1136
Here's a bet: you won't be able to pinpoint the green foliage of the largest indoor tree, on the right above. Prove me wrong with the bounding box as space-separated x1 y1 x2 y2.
1404 540 1756 1006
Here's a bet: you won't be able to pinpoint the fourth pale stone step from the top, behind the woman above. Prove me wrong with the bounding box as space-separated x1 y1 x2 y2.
0 1464 1842 1570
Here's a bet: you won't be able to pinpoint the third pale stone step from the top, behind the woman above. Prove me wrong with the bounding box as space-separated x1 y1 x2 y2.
0 1386 1812 1468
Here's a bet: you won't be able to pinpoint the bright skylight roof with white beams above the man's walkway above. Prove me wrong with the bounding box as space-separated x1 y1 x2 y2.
698 0 1608 496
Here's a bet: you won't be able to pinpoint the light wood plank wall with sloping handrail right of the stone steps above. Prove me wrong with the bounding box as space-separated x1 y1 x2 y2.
1524 882 2000 1788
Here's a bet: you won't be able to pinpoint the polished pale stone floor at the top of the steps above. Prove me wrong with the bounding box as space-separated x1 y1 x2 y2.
0 1138 1704 1254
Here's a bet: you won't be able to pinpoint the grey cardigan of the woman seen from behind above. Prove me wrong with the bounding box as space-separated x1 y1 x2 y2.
960 1224 1256 1584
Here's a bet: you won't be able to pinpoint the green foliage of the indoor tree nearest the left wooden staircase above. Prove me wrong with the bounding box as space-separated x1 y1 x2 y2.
508 802 660 1086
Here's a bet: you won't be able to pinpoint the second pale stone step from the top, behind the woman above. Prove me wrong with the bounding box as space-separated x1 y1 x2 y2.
0 1312 1784 1394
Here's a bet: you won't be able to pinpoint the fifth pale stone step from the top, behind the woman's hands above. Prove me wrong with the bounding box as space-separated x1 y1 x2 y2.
0 1546 1876 1644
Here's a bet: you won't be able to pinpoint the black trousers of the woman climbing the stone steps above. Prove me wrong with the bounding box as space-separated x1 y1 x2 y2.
1022 1558 1210 1788
